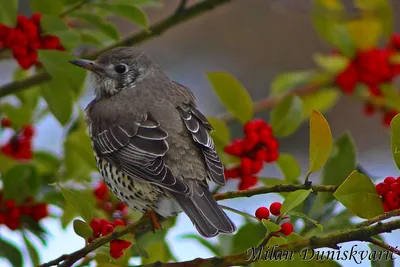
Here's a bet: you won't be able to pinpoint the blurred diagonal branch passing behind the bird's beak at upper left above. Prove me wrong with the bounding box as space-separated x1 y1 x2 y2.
0 0 232 97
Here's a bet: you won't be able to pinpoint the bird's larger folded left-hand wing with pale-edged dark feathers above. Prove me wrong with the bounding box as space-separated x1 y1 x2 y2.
92 114 190 195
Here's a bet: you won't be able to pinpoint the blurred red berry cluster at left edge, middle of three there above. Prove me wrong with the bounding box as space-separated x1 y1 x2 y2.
0 118 35 160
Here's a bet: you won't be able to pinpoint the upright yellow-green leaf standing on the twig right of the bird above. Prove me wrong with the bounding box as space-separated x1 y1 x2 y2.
308 110 332 173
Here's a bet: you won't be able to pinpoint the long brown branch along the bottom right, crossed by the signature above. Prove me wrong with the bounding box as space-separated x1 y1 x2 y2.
136 220 400 267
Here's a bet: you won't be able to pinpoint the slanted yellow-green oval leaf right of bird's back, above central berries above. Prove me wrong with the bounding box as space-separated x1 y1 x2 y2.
207 72 253 123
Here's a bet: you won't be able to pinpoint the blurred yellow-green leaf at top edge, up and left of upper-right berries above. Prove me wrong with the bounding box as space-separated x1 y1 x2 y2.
311 0 356 57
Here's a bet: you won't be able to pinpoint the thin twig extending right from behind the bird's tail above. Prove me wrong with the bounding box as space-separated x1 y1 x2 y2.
214 184 338 200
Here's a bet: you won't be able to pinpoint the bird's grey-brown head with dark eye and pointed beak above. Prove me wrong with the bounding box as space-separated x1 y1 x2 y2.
70 47 155 97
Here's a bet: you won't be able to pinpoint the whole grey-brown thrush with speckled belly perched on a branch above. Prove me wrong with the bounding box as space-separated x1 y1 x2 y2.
70 47 236 238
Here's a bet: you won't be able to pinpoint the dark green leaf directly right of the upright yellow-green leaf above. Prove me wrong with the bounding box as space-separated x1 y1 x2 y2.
322 133 356 185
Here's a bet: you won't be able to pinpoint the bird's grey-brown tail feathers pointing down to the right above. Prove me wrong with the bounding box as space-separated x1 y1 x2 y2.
171 181 236 237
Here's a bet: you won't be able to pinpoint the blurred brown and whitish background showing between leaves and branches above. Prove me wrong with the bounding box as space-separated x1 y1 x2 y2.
0 0 400 266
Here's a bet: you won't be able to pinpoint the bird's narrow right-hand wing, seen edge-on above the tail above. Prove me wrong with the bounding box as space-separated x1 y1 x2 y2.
177 105 225 185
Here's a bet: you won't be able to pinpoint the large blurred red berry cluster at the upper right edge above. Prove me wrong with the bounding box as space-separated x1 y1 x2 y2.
335 34 400 126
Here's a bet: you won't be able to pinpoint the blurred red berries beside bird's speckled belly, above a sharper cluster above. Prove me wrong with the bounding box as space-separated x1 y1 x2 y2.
94 182 128 221
